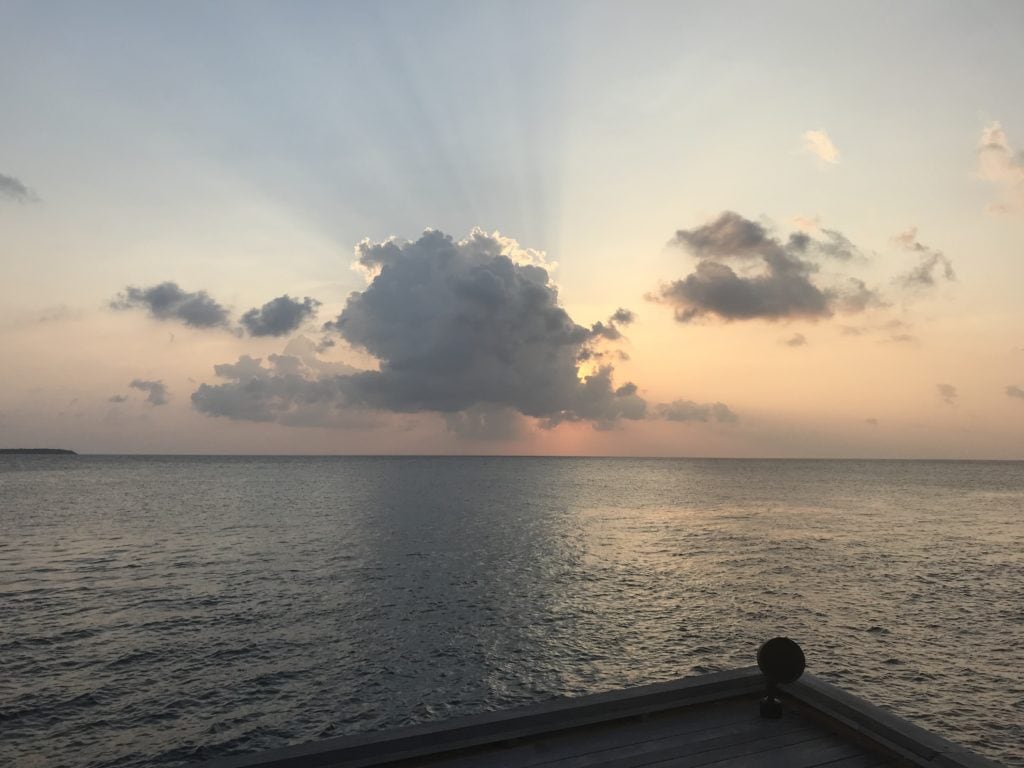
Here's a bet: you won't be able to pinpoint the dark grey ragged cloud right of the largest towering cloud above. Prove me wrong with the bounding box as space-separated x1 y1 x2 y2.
652 211 881 323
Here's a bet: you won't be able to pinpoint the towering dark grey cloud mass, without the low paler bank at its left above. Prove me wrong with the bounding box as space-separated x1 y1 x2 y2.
327 230 645 426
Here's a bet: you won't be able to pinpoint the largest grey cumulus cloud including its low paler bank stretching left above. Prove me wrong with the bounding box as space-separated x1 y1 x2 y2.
193 230 728 439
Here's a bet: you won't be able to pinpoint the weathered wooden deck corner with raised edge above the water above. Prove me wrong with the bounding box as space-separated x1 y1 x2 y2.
199 668 997 768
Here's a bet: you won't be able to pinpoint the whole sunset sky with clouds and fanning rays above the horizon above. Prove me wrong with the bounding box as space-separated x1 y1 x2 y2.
0 0 1024 460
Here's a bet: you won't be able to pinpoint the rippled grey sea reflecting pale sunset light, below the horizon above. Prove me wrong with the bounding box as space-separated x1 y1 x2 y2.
0 457 1024 766
